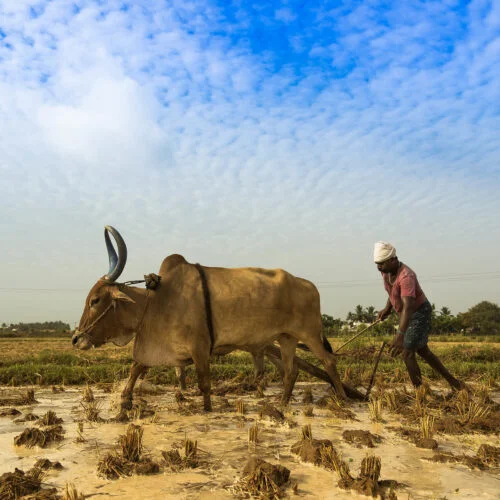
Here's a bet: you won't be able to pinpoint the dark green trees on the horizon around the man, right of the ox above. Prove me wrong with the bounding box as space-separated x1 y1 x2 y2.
321 300 500 335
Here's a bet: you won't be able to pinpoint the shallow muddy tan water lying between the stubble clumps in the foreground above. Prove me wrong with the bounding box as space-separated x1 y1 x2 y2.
0 383 500 500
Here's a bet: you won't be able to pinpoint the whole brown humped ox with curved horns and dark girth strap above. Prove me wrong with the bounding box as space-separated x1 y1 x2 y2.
72 226 346 416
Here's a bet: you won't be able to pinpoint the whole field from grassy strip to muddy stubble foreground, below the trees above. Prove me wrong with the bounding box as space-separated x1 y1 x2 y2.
0 338 500 500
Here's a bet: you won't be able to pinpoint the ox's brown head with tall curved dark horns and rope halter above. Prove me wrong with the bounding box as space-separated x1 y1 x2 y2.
72 226 135 349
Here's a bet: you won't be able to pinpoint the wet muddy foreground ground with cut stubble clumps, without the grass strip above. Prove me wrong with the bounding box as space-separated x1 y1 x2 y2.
0 378 500 499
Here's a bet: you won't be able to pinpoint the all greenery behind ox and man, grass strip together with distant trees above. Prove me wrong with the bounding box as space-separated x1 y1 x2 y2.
0 301 500 385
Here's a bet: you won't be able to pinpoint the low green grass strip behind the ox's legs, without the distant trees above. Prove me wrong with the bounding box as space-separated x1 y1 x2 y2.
0 332 500 386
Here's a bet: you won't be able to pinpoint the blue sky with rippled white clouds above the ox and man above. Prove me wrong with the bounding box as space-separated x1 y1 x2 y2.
0 0 500 326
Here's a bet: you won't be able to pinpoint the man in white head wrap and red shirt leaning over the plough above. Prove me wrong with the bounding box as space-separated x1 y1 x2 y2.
373 241 466 390
